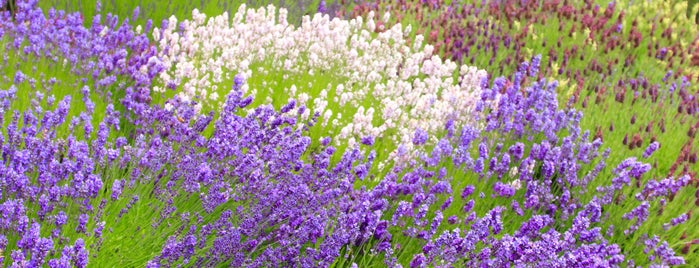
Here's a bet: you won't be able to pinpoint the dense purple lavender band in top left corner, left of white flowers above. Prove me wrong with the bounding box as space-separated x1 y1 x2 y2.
0 0 163 112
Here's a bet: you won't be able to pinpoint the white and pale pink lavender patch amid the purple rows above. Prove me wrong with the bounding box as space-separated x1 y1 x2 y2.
153 5 486 157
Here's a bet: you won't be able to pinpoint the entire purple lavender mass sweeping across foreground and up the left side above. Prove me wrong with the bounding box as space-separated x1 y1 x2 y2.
0 2 693 267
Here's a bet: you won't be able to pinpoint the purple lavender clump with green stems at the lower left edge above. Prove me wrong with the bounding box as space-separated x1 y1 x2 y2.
0 73 117 267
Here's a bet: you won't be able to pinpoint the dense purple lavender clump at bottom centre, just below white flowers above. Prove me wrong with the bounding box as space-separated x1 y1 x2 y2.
142 88 390 267
